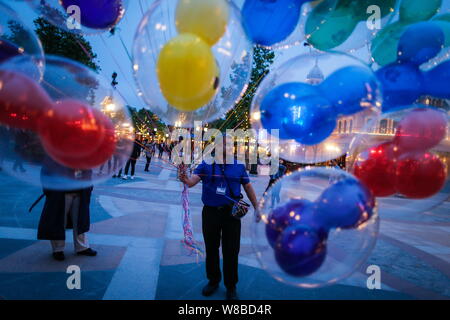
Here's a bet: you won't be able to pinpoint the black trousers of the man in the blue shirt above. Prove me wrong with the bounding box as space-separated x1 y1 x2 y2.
202 206 241 289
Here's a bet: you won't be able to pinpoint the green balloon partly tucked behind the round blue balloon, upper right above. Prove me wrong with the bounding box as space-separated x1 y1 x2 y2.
371 21 409 66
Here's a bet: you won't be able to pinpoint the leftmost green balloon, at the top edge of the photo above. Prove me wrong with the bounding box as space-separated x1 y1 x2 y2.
305 0 358 51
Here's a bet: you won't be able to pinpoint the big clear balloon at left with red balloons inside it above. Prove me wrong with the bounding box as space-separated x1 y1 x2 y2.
0 56 134 190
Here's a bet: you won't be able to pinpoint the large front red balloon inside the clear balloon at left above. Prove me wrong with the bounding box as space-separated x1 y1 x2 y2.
39 100 116 170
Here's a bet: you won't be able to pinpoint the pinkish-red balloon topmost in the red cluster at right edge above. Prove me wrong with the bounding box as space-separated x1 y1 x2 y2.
394 109 447 153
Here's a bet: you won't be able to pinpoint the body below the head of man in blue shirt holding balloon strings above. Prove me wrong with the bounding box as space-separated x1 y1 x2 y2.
180 162 259 300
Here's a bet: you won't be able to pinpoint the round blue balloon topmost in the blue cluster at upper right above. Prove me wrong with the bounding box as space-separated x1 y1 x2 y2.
397 22 445 65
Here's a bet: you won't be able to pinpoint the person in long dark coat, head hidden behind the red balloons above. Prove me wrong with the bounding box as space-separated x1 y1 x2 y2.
37 159 97 261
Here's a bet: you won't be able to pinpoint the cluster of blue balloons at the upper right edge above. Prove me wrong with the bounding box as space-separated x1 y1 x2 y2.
376 22 450 112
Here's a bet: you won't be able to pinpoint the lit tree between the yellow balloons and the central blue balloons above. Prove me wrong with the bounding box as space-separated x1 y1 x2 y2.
211 46 275 131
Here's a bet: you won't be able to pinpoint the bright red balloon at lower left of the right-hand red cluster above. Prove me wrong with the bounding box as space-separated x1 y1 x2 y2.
353 142 396 197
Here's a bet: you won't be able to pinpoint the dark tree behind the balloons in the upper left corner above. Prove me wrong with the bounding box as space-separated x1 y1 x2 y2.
34 18 100 72
